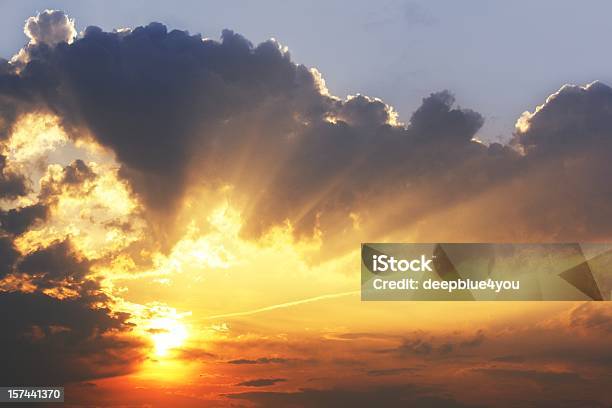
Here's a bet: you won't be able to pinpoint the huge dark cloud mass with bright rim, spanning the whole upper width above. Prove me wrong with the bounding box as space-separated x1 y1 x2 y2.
0 10 612 245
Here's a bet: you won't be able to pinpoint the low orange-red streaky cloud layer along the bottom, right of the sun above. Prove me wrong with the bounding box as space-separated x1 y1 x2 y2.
196 302 612 407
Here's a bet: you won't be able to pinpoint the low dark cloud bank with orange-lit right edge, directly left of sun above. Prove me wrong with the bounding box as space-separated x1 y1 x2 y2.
0 292 142 386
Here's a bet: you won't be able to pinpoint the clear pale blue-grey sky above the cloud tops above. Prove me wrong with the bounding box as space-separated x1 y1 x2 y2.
0 0 612 140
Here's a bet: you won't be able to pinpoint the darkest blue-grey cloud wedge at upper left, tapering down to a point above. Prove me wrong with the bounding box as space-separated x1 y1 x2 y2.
24 23 310 215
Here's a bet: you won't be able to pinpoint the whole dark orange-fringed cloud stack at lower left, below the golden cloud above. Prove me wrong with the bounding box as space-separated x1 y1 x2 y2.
0 238 145 385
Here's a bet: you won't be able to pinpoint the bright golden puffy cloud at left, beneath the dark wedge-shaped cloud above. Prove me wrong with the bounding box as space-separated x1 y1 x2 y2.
15 155 146 260
